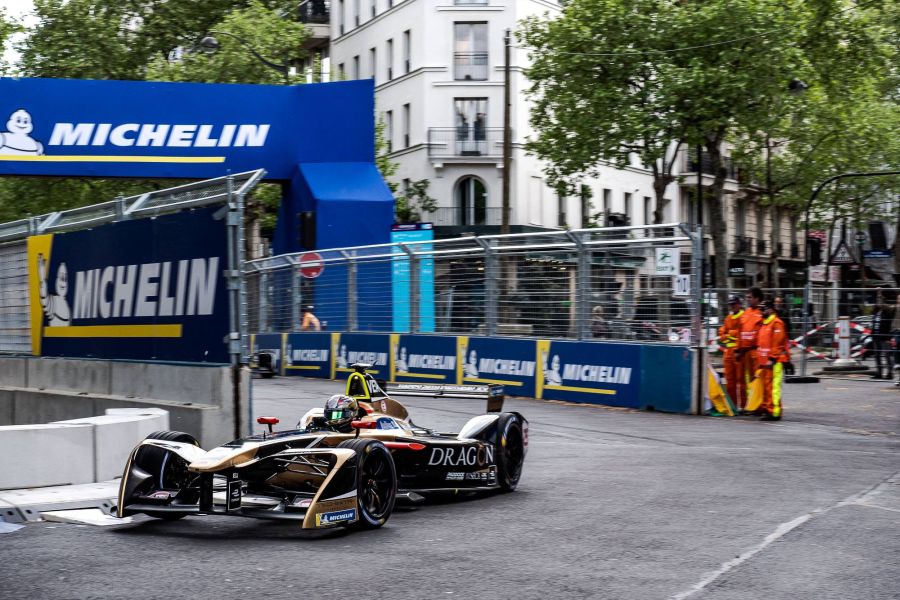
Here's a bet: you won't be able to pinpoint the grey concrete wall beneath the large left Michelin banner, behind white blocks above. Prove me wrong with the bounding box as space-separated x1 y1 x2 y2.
0 356 250 447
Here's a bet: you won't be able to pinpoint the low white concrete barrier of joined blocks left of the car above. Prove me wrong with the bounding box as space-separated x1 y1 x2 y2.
0 408 169 489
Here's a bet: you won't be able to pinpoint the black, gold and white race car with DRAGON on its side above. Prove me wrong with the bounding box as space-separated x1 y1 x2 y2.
114 364 528 529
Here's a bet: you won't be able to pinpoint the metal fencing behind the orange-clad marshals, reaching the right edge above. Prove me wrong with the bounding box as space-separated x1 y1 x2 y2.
703 286 900 378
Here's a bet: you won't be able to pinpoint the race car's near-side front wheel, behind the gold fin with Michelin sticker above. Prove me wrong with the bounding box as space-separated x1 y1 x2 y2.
338 438 397 529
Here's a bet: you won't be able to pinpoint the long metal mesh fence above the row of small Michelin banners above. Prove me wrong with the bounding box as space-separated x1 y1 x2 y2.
244 224 701 344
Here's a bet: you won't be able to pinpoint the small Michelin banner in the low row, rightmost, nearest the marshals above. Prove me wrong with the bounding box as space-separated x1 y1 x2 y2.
535 340 641 408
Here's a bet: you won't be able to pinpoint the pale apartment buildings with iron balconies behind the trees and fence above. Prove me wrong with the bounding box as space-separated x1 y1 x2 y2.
314 0 802 286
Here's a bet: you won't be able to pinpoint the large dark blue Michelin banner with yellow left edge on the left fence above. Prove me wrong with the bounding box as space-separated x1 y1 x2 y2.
28 207 229 363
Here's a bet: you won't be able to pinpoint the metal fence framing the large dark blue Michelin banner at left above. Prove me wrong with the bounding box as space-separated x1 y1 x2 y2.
0 170 265 356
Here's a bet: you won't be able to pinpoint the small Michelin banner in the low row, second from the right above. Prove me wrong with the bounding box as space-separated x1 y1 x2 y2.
457 336 536 398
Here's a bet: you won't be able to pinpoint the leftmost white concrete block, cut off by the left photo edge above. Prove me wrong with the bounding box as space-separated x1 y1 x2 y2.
0 424 93 489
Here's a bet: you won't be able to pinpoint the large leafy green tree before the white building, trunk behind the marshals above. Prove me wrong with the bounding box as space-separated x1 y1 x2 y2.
523 0 892 290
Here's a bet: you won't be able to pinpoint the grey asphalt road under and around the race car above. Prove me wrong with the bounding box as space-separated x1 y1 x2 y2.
0 378 900 600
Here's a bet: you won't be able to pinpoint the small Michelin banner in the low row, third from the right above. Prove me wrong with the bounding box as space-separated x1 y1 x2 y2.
391 334 457 384
